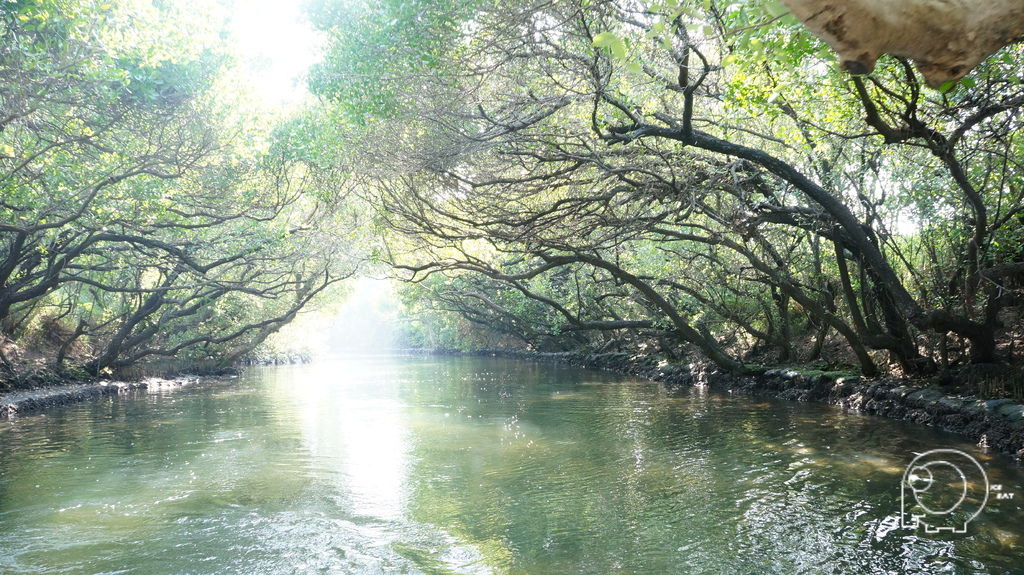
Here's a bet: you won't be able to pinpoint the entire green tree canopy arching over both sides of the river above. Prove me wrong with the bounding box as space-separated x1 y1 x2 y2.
0 0 1024 386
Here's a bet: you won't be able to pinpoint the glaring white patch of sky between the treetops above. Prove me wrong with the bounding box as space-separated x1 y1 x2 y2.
230 0 319 106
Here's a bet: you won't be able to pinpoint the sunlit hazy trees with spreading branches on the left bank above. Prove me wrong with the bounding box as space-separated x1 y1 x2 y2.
0 0 351 384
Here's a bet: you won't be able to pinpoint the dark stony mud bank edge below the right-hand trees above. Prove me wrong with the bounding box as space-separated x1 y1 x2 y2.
460 343 1024 458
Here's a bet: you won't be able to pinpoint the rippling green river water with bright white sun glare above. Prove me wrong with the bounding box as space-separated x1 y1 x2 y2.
0 358 1024 575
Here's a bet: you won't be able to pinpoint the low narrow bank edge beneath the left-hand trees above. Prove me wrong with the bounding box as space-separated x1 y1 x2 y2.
0 375 234 418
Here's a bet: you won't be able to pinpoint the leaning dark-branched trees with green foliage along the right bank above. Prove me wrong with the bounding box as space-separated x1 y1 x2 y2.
314 0 1024 374
